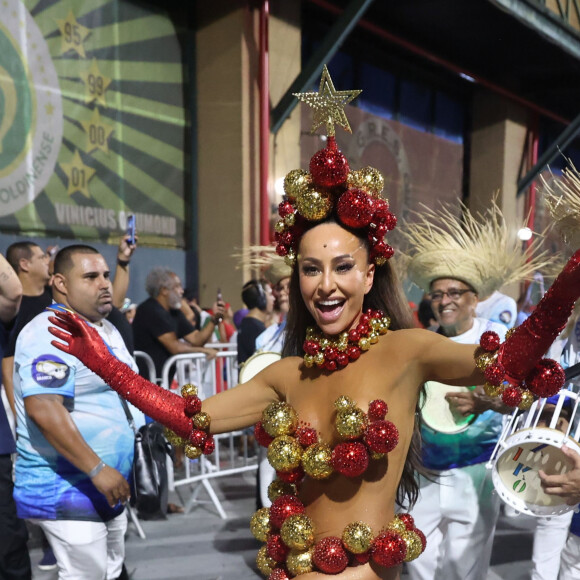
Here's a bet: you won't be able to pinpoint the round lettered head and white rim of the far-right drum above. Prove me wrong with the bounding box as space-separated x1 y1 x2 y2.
492 427 580 516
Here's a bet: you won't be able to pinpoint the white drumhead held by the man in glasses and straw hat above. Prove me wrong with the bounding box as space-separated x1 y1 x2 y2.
420 381 475 434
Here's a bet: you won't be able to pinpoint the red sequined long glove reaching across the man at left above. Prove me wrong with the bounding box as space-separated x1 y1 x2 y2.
48 311 192 440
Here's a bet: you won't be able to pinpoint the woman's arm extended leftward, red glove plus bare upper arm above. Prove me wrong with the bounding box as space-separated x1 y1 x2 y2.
49 311 279 439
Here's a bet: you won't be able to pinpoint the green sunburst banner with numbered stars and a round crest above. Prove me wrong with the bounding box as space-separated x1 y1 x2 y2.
0 0 186 247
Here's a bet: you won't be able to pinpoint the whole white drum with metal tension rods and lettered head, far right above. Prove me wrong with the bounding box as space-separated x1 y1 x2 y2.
487 390 580 517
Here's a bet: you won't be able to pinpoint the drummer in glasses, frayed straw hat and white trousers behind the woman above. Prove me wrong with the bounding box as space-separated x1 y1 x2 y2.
401 206 548 580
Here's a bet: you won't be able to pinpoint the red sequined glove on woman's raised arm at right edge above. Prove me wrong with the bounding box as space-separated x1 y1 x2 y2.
498 250 580 384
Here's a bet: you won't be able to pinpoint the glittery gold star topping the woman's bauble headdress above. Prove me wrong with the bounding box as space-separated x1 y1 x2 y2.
293 65 362 137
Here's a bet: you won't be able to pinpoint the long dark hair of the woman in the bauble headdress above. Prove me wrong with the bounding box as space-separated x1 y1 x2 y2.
282 218 424 506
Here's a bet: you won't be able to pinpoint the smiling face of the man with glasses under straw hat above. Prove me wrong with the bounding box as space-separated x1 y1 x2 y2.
431 278 477 336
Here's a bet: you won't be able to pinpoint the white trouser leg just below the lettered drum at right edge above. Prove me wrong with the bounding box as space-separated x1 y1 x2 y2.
530 511 580 580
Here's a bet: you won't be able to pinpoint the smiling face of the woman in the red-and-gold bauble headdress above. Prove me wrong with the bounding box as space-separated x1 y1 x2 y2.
297 223 375 336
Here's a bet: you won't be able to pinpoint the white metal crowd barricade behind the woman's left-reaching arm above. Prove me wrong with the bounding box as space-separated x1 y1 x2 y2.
161 343 258 519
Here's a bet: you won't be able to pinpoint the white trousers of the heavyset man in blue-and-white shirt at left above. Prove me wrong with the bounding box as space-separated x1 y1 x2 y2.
32 512 127 580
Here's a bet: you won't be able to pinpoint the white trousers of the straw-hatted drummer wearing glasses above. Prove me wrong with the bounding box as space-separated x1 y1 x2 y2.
408 463 499 580
